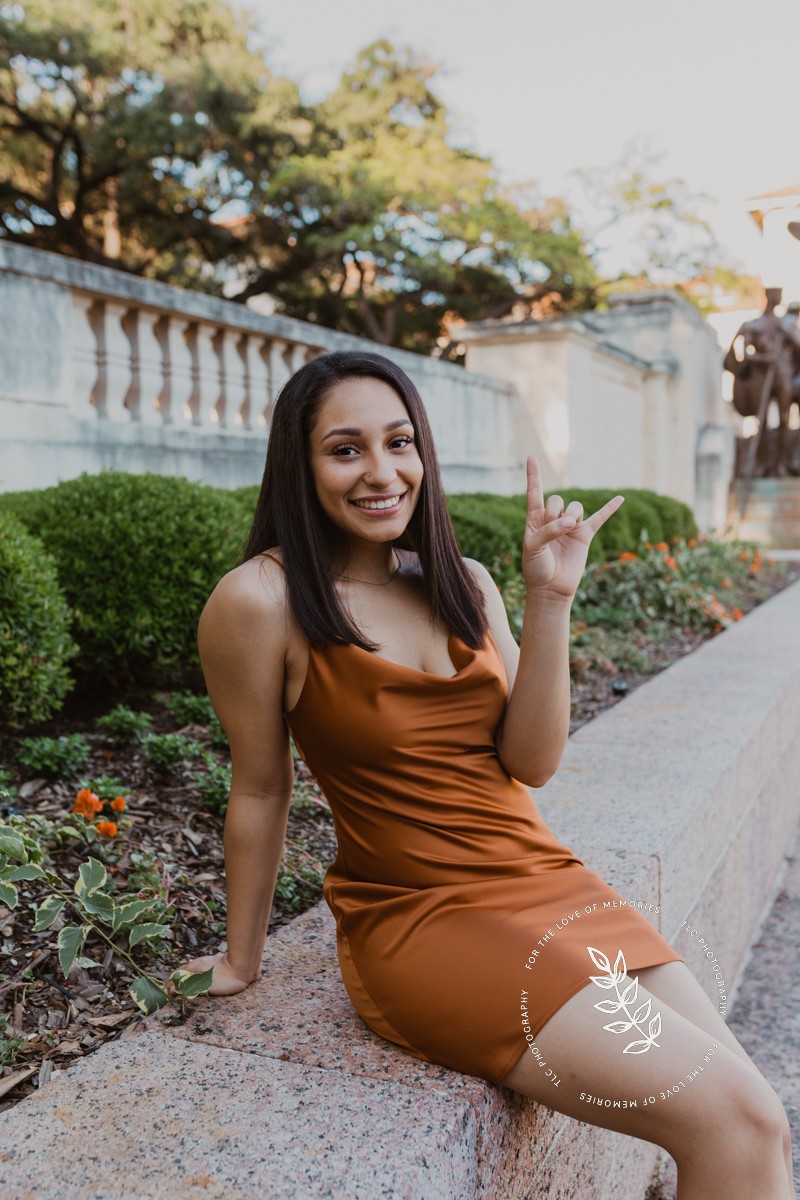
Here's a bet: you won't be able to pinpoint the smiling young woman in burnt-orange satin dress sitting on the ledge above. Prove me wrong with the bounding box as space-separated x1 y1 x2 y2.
190 354 794 1200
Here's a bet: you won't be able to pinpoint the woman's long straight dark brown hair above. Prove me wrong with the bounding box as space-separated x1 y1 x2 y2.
243 352 488 650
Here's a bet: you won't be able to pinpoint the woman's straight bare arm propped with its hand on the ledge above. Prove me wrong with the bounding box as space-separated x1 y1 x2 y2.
178 558 294 995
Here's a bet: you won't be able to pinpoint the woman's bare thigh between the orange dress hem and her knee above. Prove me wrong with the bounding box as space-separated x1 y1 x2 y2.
504 964 777 1157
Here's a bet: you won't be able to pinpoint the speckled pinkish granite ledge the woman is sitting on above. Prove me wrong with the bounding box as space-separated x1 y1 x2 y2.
0 584 800 1200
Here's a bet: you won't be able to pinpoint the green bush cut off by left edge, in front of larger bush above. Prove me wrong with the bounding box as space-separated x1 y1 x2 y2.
0 510 78 725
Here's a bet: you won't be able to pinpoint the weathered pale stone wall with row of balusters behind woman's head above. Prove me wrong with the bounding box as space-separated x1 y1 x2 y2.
0 244 524 494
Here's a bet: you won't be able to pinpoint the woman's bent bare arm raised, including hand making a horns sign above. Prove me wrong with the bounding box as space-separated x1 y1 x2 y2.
472 457 622 787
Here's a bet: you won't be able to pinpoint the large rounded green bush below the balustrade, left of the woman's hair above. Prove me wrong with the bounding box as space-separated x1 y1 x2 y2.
0 470 249 678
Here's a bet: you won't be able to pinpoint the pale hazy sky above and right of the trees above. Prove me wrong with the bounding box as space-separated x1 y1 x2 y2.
247 0 800 274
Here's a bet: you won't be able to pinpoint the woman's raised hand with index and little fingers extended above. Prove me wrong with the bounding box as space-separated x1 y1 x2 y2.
522 455 625 600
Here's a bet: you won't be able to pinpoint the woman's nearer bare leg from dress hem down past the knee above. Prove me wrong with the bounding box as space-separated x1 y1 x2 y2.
504 964 794 1200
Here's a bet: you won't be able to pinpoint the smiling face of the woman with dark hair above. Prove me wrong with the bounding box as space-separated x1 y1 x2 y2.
309 378 422 542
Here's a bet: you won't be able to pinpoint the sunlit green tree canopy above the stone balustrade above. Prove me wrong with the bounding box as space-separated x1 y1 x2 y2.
0 0 743 360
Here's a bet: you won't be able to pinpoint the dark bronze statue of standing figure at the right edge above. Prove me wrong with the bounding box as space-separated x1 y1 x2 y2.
723 288 800 475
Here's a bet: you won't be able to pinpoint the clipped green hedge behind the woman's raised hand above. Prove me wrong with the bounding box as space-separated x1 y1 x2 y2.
447 487 697 582
